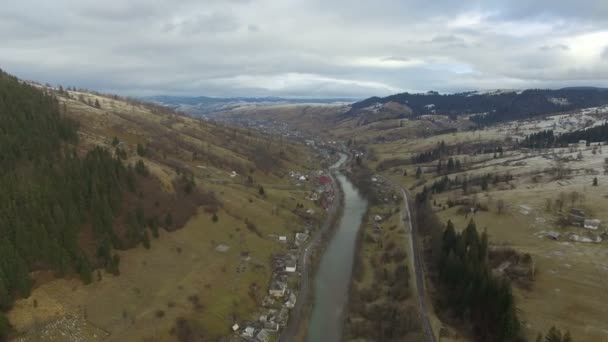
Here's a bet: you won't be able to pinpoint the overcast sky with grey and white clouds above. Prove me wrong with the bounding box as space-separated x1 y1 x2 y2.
0 0 608 98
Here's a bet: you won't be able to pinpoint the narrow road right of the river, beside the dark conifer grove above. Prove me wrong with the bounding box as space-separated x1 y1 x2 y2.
387 179 436 342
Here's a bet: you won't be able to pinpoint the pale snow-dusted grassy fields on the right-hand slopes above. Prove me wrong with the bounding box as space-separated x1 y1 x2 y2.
368 110 608 341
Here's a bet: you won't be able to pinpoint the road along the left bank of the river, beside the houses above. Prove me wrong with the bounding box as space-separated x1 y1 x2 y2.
280 156 343 342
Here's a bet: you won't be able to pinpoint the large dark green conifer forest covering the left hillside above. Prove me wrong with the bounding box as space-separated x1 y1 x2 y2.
0 72 142 338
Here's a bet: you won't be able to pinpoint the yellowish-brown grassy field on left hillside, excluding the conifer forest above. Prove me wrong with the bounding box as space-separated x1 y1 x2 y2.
9 87 323 341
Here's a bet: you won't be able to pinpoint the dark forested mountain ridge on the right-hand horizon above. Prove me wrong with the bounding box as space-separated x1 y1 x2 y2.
341 87 608 124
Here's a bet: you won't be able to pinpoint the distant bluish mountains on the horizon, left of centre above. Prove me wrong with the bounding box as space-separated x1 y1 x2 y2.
142 95 355 116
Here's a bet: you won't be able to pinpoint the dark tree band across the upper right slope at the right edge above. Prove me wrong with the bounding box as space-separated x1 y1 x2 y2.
520 122 608 148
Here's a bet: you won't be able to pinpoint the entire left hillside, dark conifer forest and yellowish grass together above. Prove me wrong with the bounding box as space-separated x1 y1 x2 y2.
0 74 323 341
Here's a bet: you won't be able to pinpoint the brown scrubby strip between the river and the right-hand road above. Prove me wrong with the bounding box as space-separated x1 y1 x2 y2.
344 162 425 341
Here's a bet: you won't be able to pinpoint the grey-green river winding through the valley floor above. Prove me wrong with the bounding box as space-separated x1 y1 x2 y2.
308 155 367 342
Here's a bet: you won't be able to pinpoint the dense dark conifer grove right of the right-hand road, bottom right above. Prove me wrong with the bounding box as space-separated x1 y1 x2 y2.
414 191 520 341
